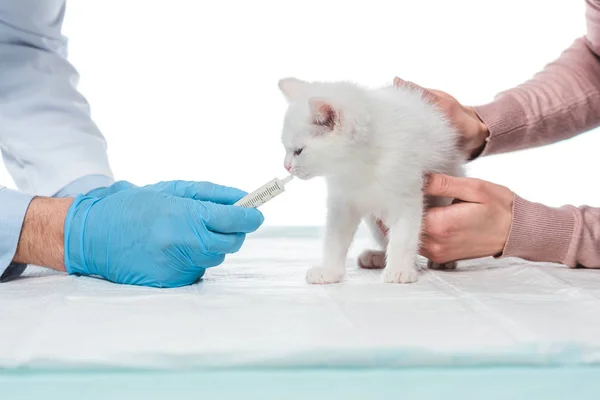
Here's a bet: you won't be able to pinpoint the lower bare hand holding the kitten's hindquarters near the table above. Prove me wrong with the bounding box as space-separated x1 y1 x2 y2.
421 175 514 264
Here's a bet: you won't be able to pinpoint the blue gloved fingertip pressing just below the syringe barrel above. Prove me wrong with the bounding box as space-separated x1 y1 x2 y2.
200 203 265 233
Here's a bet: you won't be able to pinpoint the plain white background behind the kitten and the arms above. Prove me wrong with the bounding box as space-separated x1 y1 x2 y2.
0 0 600 225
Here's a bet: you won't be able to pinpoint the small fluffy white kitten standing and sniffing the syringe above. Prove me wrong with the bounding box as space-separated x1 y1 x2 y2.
279 78 464 283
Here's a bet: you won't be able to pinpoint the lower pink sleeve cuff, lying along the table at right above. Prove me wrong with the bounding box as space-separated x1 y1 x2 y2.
502 196 600 268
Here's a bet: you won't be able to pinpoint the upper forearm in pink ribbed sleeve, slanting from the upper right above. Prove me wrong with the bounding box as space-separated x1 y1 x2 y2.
475 38 600 155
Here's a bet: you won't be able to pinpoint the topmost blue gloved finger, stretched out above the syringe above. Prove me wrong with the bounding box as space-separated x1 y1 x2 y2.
146 181 247 204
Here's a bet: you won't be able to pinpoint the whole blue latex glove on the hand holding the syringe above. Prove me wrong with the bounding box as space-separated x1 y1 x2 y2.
65 181 263 287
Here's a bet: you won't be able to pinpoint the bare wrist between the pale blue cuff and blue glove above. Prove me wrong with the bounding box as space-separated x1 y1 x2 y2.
13 197 73 271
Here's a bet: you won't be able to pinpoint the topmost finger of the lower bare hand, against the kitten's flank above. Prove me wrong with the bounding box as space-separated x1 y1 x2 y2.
424 174 487 203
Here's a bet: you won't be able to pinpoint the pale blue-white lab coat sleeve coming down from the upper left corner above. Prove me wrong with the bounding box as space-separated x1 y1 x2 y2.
0 0 112 197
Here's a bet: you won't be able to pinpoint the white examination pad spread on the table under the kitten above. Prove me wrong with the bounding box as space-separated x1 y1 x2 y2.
0 228 600 368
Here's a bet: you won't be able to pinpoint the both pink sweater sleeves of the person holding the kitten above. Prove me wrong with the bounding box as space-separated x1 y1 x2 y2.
475 0 600 268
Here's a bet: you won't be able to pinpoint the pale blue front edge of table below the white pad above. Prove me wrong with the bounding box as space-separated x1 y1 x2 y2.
0 366 600 400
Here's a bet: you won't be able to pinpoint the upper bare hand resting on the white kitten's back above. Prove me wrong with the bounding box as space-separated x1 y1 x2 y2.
394 77 490 159
